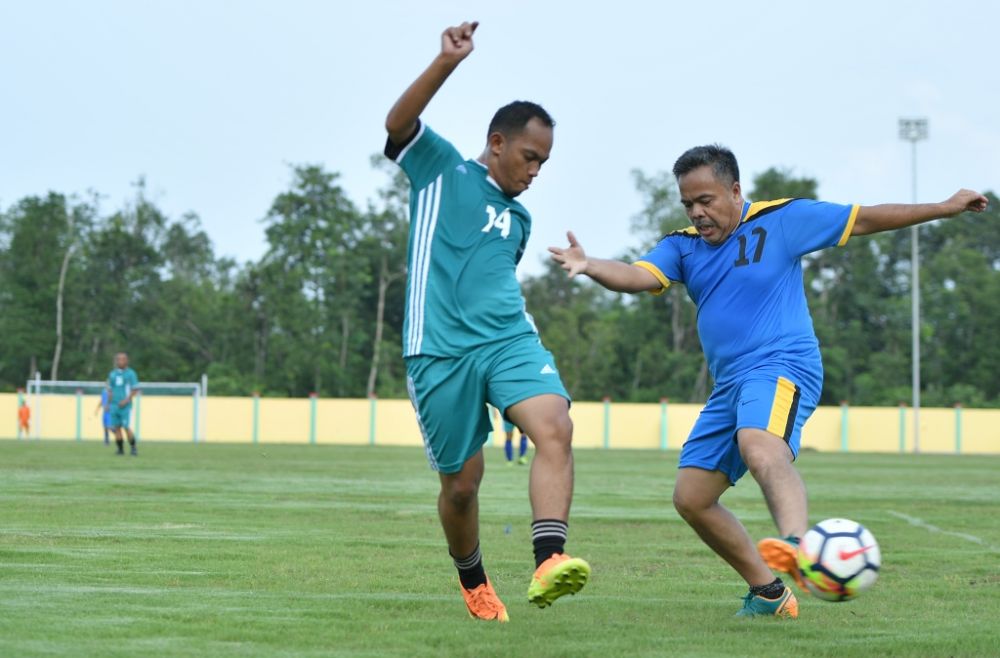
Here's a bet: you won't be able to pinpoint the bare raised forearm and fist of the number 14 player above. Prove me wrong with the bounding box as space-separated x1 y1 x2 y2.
385 21 479 144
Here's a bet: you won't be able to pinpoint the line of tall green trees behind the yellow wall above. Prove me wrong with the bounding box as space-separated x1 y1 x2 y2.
0 158 1000 406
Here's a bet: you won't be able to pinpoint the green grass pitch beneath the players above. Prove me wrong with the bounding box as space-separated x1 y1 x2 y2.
0 442 1000 658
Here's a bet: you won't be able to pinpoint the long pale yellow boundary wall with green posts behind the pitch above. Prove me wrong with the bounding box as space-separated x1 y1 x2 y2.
0 393 1000 454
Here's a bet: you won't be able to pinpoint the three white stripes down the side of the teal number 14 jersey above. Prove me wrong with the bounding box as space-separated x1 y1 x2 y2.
406 175 441 356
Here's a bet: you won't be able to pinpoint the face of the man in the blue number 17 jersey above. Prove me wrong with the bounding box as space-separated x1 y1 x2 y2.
677 165 743 244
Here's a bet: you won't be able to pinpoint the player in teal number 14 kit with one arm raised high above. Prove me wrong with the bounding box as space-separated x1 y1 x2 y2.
385 23 590 622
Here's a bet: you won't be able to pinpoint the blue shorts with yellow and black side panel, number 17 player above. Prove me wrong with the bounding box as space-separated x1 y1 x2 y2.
679 367 823 485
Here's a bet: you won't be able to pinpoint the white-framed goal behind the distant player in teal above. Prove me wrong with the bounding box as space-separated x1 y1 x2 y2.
25 373 208 443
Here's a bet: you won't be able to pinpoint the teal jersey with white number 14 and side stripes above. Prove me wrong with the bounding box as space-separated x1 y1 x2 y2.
385 122 535 357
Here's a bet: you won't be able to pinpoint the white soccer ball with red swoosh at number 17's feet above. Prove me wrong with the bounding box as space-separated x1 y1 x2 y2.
799 519 882 601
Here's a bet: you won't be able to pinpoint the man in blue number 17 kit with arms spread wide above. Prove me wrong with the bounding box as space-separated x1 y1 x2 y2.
550 145 987 618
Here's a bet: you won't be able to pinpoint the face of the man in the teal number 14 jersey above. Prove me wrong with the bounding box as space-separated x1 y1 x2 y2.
488 118 552 197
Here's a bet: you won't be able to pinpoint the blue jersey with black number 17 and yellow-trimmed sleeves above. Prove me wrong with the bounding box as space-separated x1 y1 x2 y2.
636 199 858 384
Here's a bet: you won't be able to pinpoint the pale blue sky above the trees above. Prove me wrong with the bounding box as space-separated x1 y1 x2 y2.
0 0 1000 276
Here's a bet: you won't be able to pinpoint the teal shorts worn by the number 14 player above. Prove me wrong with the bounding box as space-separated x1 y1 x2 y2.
406 334 570 473
